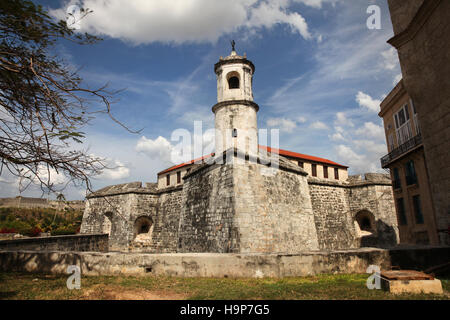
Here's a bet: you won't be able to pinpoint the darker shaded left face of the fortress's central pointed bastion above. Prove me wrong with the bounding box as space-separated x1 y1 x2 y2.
179 165 240 253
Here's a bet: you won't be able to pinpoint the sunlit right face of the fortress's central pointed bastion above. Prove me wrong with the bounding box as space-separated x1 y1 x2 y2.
233 160 319 253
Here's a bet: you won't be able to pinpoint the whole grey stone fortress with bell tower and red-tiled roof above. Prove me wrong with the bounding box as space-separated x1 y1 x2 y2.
81 46 398 254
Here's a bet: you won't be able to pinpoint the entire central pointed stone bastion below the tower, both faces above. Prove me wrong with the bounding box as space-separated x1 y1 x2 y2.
179 155 318 253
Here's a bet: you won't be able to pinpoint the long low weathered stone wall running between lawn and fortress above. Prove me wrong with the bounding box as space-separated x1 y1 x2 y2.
0 247 450 278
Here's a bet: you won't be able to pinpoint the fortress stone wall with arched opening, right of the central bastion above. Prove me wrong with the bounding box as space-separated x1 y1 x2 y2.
308 174 398 250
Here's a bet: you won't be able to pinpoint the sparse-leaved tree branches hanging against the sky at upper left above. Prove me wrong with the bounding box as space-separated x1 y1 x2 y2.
0 0 134 192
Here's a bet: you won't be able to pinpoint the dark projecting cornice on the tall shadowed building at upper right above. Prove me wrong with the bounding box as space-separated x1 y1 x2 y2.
387 0 442 49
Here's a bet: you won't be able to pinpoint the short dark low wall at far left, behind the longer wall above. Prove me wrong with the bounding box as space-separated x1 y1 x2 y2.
0 234 108 252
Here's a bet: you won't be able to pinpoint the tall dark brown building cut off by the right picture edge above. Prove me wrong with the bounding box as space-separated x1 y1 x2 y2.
388 0 450 245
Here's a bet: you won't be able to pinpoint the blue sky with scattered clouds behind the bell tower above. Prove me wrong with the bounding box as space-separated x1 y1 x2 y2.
0 0 401 199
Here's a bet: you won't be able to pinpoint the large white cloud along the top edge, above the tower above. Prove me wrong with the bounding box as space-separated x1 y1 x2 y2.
50 0 312 45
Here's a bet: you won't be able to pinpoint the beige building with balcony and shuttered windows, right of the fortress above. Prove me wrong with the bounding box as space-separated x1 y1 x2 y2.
378 80 439 244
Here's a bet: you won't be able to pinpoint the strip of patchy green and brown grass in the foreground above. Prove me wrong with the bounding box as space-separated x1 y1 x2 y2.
0 273 450 300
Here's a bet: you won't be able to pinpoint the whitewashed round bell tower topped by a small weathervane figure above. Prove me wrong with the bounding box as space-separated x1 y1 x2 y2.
212 40 259 155
